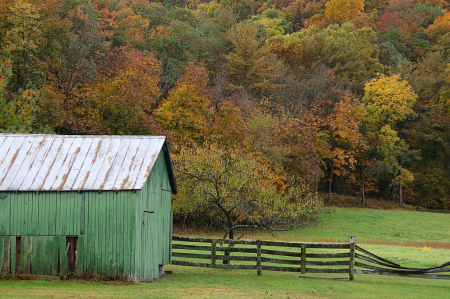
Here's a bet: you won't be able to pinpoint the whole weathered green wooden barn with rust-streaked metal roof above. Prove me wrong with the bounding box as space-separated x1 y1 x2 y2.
0 134 176 281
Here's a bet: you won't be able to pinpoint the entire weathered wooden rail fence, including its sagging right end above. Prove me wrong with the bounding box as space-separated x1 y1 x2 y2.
171 236 450 280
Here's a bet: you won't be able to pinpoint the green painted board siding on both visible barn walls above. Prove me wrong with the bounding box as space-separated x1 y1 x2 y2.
0 152 172 281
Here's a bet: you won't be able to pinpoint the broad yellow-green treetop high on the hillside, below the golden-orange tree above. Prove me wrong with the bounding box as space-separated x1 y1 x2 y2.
266 23 383 94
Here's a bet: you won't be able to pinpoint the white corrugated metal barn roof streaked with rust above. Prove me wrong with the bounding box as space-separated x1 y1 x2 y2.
0 134 171 192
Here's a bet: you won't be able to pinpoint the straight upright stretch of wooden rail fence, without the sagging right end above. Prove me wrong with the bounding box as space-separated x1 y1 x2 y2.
172 236 354 278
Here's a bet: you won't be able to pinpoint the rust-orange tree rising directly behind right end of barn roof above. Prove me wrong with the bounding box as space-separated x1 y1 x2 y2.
92 50 161 135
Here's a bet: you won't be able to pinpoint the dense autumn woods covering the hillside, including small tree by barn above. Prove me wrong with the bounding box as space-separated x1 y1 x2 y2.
0 0 450 236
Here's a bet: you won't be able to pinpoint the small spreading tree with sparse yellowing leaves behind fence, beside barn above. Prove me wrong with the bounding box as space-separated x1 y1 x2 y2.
173 145 321 239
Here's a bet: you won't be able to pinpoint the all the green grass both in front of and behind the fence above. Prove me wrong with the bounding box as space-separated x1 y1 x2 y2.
0 208 450 298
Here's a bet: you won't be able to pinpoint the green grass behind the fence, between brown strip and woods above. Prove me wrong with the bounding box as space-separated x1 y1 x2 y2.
178 207 450 248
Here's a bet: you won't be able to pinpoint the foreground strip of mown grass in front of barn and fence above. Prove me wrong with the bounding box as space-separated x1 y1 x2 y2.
0 266 450 299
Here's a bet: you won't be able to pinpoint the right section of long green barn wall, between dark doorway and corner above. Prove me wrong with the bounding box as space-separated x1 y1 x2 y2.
78 191 141 278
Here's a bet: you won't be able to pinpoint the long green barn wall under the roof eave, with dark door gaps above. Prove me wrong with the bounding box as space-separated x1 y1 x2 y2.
0 191 141 277
